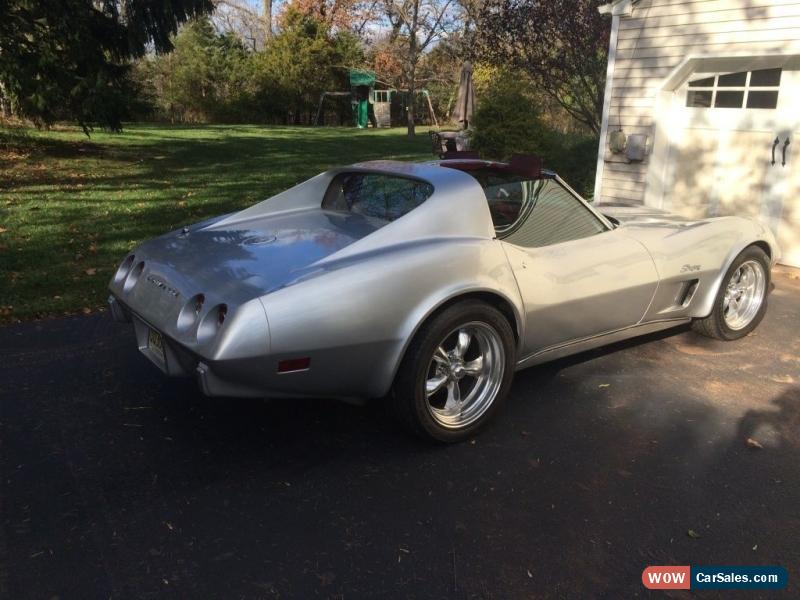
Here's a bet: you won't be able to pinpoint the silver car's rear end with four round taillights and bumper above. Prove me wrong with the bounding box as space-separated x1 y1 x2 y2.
108 247 269 396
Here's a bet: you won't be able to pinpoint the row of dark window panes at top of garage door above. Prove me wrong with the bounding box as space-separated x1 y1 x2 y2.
686 69 781 109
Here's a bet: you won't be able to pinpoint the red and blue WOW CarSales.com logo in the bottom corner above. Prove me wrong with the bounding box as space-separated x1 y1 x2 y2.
642 566 789 590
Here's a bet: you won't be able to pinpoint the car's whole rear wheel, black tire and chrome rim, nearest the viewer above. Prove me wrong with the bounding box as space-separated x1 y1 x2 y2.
390 300 516 443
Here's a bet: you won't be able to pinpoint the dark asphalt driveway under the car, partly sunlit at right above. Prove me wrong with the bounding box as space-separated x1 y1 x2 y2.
0 269 800 599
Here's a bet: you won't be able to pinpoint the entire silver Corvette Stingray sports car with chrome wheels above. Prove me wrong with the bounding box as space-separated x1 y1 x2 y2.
109 156 778 441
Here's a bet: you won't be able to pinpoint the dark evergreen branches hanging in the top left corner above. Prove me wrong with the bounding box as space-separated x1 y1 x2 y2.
0 0 213 132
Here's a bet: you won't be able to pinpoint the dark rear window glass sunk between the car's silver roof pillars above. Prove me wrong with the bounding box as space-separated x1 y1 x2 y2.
322 173 433 222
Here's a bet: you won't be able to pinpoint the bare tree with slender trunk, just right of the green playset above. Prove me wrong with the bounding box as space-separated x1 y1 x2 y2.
384 0 460 137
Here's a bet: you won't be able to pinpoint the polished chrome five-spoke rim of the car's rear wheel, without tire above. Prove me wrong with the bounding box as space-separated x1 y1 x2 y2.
425 321 505 429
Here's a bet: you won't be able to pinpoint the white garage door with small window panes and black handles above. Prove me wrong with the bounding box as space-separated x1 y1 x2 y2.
665 68 800 267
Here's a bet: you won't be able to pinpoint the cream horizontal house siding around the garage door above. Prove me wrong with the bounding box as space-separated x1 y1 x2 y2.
595 0 800 203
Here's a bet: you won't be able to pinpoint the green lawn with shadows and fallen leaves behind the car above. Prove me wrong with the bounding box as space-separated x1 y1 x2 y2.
0 125 433 323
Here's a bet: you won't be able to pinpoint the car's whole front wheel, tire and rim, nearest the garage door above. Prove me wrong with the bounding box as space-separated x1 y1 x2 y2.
692 246 770 341
